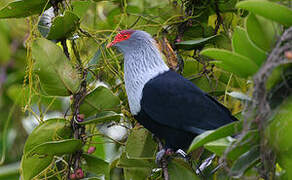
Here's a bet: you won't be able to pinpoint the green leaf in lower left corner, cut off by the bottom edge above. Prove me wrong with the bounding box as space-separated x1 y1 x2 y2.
20 153 54 180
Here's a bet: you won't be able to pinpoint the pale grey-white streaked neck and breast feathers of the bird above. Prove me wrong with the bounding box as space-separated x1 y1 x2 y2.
124 39 169 115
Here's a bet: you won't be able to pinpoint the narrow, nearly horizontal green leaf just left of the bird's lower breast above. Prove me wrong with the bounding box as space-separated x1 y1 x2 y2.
78 111 123 124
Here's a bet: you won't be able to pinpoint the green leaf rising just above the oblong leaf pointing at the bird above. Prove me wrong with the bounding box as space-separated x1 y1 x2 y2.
232 27 267 66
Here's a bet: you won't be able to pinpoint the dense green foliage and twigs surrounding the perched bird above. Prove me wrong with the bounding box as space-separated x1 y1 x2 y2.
0 0 292 180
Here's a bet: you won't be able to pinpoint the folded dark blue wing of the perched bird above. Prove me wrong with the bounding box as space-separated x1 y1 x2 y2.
141 71 235 134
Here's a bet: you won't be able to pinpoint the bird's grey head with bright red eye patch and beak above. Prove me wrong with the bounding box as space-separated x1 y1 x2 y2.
106 30 153 54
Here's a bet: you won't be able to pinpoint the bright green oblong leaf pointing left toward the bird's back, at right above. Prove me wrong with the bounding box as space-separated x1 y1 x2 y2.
201 48 258 78
